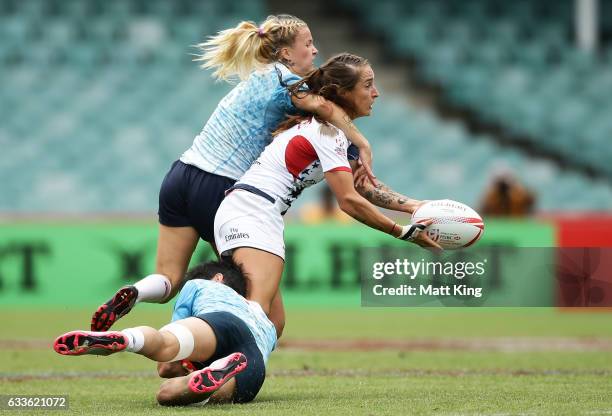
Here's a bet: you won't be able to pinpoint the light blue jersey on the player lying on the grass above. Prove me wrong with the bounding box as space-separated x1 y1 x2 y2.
172 279 276 362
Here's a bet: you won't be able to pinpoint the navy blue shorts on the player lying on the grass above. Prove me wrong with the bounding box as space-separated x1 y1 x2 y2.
198 312 266 403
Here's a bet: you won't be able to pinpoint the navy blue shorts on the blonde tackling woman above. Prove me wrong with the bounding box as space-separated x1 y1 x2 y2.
158 160 236 244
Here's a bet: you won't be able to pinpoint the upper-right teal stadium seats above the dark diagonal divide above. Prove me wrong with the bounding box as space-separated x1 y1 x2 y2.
341 0 612 178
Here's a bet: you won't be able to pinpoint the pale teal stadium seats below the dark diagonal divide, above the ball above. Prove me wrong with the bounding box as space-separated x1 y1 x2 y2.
357 97 612 211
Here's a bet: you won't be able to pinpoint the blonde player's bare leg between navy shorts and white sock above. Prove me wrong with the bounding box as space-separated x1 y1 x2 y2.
155 224 200 302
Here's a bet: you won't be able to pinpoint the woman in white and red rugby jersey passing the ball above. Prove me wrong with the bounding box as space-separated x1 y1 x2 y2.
215 53 441 336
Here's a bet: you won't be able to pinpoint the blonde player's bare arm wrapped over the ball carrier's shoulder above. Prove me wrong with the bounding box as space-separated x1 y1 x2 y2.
291 94 376 184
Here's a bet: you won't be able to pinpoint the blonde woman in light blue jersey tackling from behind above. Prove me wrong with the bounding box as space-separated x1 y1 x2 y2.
91 15 373 331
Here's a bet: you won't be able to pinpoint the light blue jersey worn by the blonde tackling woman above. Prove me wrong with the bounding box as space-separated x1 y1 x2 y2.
181 63 300 180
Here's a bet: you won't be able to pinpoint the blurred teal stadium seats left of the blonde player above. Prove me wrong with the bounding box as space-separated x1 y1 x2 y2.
0 0 246 212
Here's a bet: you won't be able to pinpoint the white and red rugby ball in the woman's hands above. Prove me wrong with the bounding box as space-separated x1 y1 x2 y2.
412 199 484 250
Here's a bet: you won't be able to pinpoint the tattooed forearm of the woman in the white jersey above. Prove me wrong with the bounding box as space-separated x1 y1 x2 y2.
350 161 423 214
